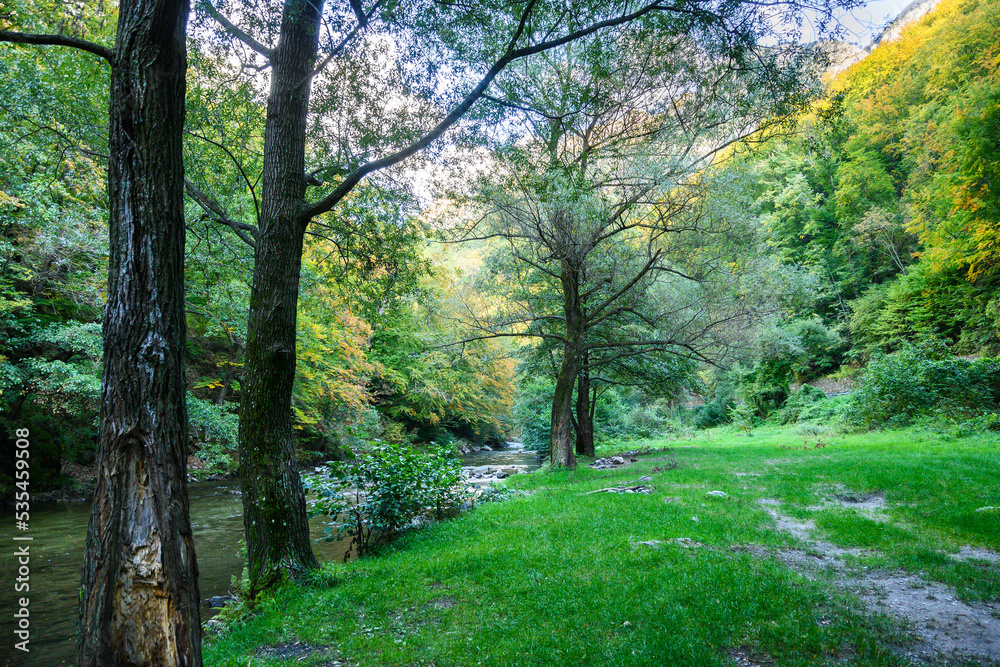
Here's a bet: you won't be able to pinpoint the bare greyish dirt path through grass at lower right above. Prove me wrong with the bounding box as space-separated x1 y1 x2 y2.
757 498 1000 663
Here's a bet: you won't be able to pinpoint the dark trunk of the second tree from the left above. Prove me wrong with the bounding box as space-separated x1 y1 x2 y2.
239 0 323 600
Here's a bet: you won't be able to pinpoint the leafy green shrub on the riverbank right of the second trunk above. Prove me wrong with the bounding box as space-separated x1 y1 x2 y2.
303 440 468 556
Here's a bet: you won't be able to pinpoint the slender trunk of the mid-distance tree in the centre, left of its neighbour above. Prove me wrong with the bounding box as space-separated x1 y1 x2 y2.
549 259 586 469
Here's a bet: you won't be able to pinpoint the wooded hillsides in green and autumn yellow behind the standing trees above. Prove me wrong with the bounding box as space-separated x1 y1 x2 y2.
0 0 1000 496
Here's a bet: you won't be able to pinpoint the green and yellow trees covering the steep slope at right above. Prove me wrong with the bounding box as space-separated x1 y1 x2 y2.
757 0 1000 359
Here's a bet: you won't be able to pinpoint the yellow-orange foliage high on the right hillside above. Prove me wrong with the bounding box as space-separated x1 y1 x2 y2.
832 0 1000 280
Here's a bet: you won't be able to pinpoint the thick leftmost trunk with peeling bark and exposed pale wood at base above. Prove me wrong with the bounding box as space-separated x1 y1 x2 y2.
80 0 201 667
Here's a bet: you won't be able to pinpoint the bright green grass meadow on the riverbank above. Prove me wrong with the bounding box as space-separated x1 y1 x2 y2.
205 428 1000 667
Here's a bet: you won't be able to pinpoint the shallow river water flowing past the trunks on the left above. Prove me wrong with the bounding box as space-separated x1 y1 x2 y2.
0 448 538 667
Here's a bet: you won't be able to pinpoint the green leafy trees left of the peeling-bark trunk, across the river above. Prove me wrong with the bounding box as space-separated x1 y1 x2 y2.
0 24 113 486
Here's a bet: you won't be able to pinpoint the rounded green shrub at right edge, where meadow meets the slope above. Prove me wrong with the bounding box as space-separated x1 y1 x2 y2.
847 343 1000 429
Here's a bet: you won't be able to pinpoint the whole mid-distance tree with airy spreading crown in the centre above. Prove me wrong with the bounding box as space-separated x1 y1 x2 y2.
454 25 820 468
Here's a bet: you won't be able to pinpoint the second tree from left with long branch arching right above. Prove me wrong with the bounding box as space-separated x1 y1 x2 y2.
189 0 844 598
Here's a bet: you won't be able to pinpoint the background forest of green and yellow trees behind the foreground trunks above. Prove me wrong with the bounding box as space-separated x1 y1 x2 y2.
0 2 1000 492
